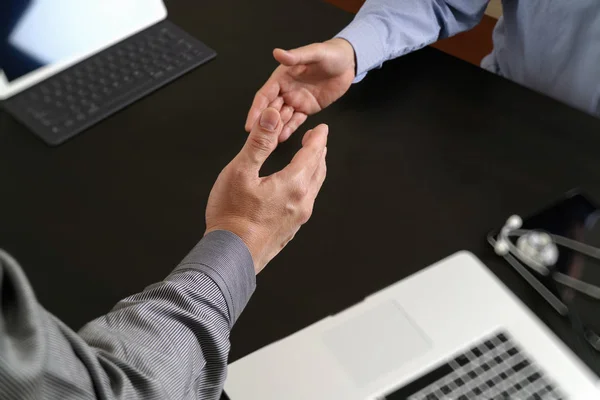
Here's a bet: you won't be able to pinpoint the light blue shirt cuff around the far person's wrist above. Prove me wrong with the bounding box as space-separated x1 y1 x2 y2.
335 19 385 83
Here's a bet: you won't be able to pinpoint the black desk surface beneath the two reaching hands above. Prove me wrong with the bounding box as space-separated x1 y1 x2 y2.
0 0 600 376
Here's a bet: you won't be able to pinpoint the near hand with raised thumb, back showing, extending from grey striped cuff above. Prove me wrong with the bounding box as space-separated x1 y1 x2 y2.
206 108 329 274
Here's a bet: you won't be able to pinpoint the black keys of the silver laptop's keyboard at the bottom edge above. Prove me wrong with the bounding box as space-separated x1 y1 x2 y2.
384 333 566 400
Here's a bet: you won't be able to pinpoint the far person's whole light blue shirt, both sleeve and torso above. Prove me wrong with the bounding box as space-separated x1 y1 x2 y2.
338 0 600 115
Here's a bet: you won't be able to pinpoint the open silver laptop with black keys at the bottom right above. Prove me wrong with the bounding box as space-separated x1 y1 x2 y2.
225 252 600 400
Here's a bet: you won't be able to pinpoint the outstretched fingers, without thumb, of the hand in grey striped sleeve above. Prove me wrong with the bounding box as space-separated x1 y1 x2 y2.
281 124 329 178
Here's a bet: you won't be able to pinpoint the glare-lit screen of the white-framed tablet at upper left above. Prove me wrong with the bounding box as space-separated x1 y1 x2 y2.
0 0 162 82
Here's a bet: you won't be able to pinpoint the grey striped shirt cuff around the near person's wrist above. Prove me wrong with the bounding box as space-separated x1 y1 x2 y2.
174 231 256 326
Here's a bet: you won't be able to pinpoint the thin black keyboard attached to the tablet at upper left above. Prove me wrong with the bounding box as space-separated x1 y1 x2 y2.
5 20 216 145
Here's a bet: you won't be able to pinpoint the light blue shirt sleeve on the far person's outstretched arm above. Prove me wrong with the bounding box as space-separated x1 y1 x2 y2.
336 0 489 82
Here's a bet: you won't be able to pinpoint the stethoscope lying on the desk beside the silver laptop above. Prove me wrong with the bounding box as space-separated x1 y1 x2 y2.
494 215 600 351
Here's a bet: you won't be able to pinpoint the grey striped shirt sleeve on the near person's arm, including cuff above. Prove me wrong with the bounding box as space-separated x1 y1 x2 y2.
0 231 256 400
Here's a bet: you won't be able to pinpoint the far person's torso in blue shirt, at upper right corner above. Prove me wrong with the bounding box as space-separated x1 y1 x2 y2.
482 0 600 115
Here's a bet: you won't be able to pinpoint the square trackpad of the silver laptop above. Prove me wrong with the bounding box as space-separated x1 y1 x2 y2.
323 301 430 386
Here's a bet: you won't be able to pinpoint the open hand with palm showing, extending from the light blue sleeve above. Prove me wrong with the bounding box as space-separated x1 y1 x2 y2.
246 38 356 142
